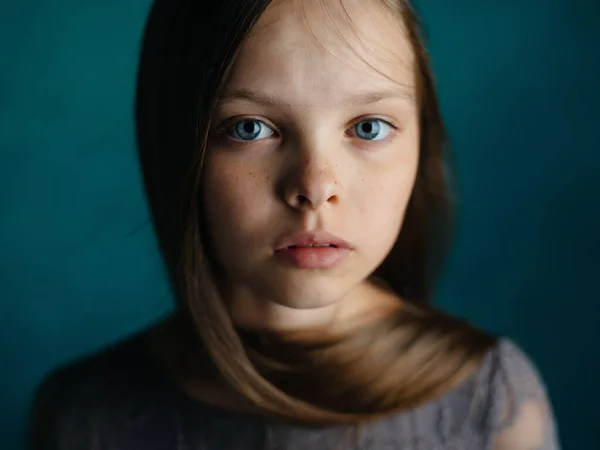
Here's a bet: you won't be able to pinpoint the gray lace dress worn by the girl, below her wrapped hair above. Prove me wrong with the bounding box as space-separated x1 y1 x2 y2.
32 339 558 450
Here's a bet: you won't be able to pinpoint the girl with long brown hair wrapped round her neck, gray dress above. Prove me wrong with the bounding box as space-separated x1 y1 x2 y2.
32 0 558 450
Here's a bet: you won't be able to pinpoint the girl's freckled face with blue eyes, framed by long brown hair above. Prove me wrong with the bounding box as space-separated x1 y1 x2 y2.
203 0 419 329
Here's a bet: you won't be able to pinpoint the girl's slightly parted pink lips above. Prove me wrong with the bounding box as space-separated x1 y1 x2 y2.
274 232 352 270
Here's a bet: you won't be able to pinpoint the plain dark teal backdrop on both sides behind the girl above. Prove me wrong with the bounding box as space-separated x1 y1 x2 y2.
0 0 600 450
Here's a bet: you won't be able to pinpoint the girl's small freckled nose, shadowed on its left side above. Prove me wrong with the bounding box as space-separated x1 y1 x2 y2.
284 155 341 210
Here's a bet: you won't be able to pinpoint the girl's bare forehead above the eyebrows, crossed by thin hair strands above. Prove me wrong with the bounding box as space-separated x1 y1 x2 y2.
224 0 414 107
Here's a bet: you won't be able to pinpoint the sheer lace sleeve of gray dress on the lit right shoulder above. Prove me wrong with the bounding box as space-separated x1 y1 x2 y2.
491 340 560 450
